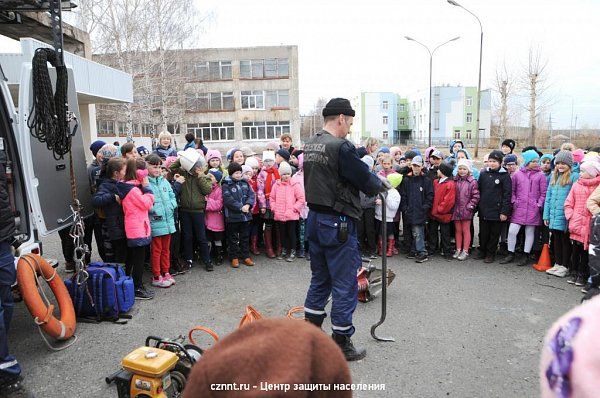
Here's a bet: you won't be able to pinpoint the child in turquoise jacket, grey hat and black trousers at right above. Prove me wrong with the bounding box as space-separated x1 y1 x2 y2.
543 150 579 278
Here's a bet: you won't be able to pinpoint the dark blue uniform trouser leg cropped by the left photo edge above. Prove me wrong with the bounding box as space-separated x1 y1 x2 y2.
0 242 21 384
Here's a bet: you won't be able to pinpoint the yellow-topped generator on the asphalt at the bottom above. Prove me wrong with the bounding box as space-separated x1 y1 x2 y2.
106 337 202 398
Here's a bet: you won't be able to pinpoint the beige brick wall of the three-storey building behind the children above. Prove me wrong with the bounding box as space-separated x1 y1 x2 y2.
94 46 300 150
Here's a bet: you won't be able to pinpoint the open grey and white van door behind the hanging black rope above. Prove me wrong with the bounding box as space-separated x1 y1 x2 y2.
17 63 93 236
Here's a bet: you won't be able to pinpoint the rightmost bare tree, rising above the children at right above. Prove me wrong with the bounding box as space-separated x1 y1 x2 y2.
522 47 554 145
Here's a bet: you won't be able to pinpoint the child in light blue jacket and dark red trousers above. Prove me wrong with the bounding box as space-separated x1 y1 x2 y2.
146 153 177 288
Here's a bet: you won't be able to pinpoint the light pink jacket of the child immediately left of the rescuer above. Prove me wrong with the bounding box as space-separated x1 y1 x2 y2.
270 179 306 221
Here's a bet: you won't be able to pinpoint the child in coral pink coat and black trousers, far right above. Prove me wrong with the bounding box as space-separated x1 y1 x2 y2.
565 161 600 286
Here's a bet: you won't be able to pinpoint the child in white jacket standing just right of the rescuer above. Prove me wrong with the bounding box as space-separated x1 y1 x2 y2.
375 173 403 257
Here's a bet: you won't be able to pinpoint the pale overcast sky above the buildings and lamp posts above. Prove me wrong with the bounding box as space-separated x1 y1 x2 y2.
0 0 600 129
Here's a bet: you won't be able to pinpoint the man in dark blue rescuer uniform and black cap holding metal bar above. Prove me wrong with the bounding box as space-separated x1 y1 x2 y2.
304 98 389 361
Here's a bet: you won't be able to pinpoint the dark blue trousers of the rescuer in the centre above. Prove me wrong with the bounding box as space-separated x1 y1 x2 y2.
304 210 361 336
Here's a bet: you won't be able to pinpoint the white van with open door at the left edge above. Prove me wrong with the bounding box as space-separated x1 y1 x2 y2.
0 64 93 257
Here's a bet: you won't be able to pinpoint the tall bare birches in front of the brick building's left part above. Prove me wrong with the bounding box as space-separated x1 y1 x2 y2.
78 0 210 143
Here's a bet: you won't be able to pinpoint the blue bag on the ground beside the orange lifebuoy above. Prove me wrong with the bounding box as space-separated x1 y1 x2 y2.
65 262 135 321
